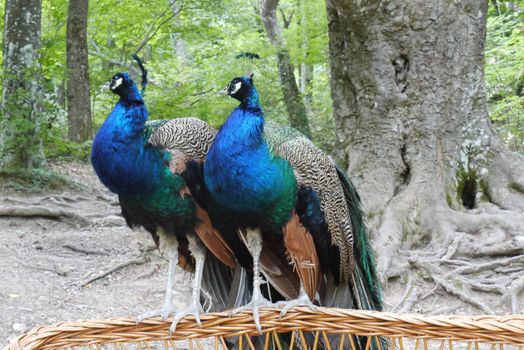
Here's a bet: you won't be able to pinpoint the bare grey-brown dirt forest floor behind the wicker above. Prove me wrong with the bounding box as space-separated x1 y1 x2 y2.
0 164 524 347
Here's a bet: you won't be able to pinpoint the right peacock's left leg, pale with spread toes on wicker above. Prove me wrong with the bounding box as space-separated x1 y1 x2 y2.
231 229 278 333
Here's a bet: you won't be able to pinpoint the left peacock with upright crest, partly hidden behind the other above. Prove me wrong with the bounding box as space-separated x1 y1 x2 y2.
91 67 237 331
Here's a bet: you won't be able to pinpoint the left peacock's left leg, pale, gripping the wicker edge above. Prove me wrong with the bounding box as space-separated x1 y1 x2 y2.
136 230 178 322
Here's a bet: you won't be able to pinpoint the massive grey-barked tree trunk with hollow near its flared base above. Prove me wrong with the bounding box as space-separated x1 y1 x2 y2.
327 0 524 296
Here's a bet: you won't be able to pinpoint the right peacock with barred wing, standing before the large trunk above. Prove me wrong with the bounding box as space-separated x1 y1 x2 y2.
204 75 382 347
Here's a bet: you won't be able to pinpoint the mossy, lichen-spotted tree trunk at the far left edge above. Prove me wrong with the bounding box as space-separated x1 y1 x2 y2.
0 0 45 170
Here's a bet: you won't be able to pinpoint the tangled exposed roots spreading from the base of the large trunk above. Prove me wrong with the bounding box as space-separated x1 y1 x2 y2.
377 176 524 314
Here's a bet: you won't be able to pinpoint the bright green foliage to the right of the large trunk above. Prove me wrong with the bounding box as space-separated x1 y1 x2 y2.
485 1 524 152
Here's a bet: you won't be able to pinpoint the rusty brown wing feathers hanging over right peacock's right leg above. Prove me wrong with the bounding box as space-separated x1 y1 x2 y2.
282 213 322 300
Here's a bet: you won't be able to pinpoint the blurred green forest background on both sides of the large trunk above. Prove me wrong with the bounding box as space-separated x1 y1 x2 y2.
0 0 524 180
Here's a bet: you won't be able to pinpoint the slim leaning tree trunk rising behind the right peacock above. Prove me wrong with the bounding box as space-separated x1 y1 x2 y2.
259 0 311 137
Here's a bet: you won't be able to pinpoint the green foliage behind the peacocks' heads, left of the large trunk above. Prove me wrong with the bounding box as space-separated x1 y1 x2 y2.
5 0 335 168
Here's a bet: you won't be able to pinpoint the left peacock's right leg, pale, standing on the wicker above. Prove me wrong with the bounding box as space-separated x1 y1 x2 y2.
169 235 206 333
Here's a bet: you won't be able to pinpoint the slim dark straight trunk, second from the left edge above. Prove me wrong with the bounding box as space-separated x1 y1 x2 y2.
67 0 92 142
